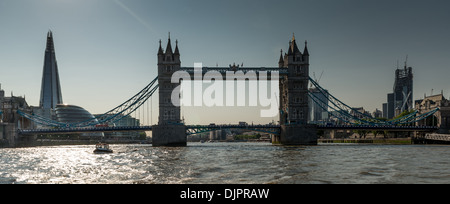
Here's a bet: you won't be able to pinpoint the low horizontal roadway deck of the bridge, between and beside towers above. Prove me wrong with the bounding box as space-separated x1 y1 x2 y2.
18 125 438 135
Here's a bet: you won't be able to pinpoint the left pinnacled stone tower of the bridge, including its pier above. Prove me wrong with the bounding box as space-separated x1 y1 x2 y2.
152 34 187 146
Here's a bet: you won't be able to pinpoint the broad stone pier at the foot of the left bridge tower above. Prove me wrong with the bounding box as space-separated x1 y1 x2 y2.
152 124 187 147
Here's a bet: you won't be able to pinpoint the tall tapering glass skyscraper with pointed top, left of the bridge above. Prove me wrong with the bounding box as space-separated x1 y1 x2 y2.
39 31 63 109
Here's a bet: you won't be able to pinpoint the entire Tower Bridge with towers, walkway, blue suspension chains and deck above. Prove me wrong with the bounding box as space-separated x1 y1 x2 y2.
10 33 439 146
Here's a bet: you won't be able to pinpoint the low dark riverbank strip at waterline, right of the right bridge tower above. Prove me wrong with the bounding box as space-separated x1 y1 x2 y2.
318 138 413 145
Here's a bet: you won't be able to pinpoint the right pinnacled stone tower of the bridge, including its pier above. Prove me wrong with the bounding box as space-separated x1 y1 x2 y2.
275 36 317 145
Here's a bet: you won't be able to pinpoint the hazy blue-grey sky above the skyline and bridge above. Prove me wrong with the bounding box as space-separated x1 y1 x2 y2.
0 0 450 124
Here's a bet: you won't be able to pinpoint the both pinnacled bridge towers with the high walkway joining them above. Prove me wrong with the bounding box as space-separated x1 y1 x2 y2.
152 36 317 146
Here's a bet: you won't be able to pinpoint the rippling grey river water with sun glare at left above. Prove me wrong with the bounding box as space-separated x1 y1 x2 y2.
0 143 450 184
